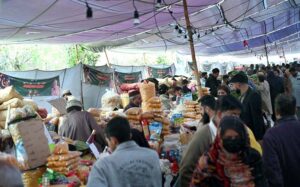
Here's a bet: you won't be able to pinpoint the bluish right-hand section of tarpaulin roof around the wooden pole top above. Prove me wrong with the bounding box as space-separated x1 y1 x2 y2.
101 0 300 55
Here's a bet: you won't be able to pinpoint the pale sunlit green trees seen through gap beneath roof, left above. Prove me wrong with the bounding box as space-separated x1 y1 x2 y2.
0 45 100 71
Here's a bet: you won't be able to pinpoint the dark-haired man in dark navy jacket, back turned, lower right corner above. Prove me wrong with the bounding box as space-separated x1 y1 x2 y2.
263 94 300 187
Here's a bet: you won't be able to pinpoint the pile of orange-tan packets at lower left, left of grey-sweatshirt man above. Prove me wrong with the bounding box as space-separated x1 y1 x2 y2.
47 142 81 175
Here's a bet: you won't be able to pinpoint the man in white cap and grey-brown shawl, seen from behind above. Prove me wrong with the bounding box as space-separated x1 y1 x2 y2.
58 97 106 151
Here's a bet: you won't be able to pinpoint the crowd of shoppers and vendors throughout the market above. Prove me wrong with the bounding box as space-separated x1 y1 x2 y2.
0 61 300 187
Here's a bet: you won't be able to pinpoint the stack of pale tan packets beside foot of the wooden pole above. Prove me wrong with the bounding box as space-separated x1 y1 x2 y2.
183 101 201 122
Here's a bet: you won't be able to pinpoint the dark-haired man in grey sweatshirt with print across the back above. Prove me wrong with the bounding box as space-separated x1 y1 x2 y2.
87 117 162 187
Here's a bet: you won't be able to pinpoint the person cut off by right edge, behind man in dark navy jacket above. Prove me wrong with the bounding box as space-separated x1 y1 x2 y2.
289 67 300 118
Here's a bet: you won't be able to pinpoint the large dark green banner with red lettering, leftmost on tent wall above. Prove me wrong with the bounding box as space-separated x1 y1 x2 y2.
0 73 60 97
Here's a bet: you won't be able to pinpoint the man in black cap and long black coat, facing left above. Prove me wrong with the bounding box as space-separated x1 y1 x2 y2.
230 71 265 141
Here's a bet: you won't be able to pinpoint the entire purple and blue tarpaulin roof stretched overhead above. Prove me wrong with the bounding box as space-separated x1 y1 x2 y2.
0 0 300 54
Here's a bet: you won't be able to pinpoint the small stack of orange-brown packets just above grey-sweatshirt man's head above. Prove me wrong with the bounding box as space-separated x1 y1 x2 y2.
125 107 143 132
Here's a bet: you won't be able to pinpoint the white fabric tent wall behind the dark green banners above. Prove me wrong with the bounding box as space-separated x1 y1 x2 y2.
1 64 175 112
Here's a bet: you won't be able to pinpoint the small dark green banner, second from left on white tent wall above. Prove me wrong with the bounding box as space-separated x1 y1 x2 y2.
83 66 112 87
